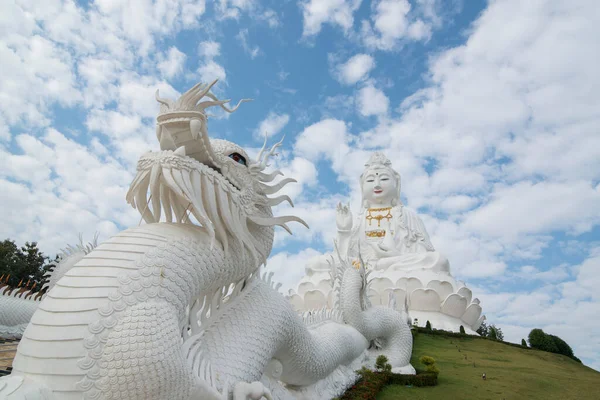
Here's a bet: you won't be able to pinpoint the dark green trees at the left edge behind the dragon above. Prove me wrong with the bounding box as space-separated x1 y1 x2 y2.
0 239 58 292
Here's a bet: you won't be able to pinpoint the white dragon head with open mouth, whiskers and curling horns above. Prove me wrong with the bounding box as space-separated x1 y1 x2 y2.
127 80 306 262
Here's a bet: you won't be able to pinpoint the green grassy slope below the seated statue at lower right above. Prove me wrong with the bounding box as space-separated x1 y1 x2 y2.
377 333 600 400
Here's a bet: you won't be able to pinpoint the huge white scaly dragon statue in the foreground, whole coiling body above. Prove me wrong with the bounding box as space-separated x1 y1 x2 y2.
0 81 414 400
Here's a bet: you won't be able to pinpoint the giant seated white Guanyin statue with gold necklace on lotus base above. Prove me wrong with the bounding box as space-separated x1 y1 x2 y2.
289 152 485 333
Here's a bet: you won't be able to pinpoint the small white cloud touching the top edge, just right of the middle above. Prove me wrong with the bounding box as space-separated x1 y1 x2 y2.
300 0 361 37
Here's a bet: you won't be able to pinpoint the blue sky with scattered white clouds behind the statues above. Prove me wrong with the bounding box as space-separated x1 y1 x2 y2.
0 0 600 369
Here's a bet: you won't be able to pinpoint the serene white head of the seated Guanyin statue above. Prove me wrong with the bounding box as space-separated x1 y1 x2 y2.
360 151 400 208
